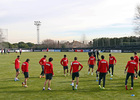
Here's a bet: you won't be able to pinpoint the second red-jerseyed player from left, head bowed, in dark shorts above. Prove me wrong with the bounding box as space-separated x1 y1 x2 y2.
21 59 30 87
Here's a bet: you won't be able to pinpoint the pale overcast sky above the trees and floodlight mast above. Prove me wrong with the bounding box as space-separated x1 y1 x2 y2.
0 0 140 43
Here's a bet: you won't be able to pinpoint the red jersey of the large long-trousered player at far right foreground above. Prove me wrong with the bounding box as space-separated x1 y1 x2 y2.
126 60 138 73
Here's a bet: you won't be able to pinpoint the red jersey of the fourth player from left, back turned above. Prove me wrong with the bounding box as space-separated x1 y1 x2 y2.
44 62 54 75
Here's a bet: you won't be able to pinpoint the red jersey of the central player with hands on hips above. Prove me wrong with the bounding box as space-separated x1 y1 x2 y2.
70 61 83 73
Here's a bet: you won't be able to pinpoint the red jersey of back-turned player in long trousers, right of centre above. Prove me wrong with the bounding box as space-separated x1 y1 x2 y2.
97 59 109 73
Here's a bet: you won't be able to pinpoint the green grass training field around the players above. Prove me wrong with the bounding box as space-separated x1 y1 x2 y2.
0 52 140 100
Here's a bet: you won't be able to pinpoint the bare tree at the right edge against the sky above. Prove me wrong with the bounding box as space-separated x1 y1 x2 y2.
134 5 140 35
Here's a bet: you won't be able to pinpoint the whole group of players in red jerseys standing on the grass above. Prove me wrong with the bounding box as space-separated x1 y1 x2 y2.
15 52 139 90
